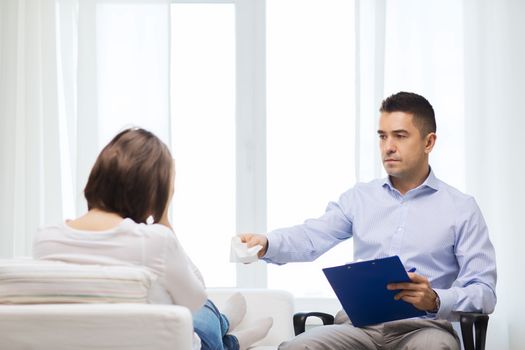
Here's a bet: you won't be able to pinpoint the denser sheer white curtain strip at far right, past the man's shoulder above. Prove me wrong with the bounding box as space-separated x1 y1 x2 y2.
464 0 525 349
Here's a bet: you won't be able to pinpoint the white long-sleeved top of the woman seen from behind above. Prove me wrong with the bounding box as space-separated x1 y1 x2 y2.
33 218 207 311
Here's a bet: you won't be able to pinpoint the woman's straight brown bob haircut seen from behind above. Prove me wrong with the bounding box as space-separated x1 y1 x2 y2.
84 128 173 223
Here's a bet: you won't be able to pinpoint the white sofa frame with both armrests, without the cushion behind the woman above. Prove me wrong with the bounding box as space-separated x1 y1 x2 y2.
0 289 294 350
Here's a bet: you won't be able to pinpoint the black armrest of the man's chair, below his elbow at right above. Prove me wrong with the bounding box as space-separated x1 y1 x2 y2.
459 312 489 350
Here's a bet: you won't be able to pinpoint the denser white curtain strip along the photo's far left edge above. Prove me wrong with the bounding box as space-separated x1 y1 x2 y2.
0 0 62 257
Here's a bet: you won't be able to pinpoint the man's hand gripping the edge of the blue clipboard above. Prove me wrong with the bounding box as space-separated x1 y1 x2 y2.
387 272 437 312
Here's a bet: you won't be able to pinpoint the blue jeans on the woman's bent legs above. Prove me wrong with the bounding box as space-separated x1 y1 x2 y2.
193 299 239 350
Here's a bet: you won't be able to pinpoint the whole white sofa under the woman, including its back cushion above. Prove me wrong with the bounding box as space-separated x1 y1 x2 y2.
0 258 294 350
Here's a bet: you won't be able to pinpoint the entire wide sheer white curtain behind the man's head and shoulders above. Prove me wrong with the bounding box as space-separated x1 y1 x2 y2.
356 0 525 349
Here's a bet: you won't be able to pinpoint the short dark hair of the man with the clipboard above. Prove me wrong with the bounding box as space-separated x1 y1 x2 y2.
379 91 436 137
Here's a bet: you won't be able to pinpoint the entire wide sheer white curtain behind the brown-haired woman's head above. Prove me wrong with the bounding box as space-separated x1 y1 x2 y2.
0 0 170 257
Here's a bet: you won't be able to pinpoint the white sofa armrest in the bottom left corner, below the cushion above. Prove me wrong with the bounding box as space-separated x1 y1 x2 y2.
0 304 193 350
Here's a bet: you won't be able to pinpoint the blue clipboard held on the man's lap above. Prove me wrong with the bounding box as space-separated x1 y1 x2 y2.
323 255 426 327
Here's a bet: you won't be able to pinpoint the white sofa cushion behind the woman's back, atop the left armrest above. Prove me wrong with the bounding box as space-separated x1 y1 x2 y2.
0 259 154 304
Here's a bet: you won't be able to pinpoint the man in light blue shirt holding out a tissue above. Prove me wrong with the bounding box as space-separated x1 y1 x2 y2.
241 92 496 350
